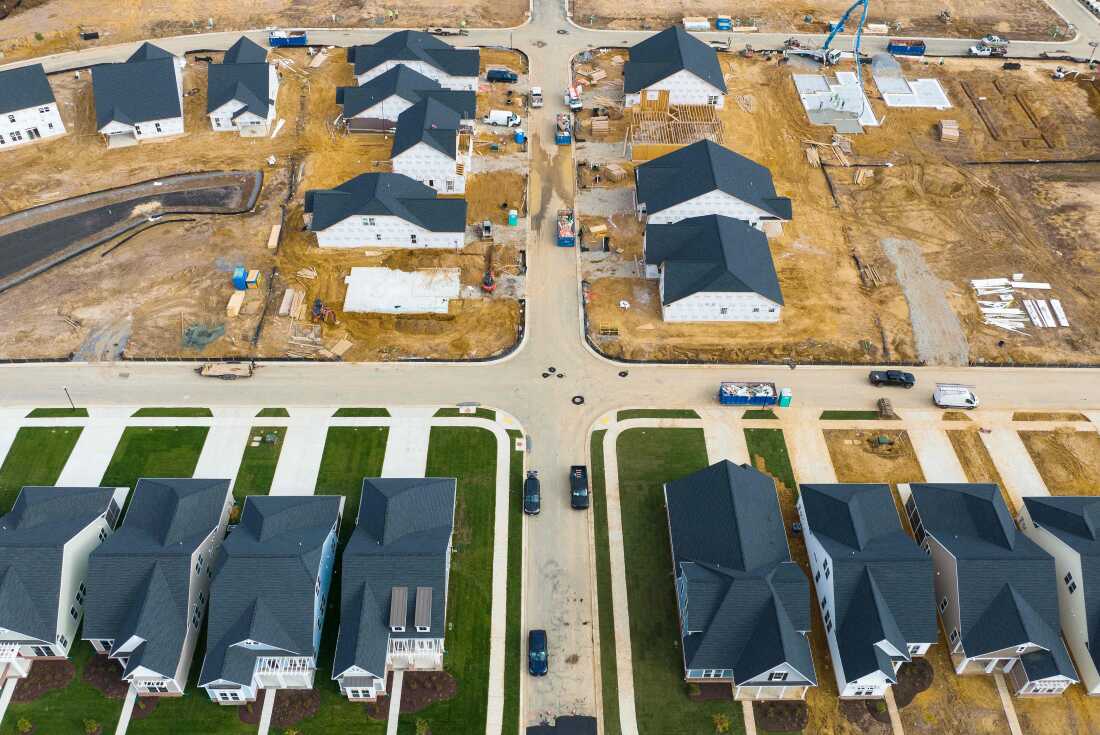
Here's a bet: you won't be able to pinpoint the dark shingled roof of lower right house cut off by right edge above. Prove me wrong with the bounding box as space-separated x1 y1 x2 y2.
1024 495 1100 672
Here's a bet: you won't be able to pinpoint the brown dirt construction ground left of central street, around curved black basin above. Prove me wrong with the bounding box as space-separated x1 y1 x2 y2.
0 52 521 360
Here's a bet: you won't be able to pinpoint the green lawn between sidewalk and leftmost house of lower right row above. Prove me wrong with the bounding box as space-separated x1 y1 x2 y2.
617 429 744 735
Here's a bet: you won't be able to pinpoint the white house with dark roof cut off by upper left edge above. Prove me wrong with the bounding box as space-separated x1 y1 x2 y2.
0 64 65 150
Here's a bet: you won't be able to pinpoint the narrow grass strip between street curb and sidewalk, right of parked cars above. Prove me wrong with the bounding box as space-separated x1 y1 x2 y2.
589 430 623 735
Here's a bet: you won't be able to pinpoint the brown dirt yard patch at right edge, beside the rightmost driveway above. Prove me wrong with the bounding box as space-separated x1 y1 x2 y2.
1020 427 1100 495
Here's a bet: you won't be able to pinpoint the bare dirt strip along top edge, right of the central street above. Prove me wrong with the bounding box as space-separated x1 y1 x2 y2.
573 0 1066 39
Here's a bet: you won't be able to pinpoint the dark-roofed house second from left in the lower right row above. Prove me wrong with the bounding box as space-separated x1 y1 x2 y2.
798 484 939 699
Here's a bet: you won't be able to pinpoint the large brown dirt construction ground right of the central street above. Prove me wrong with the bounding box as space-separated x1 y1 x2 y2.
584 55 1100 364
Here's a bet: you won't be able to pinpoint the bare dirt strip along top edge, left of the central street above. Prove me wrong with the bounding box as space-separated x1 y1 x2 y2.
0 0 527 59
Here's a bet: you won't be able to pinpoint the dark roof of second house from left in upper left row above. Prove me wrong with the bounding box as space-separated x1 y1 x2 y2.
91 43 183 130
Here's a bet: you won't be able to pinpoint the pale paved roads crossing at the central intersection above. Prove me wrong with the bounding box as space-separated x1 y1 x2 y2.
0 0 1100 724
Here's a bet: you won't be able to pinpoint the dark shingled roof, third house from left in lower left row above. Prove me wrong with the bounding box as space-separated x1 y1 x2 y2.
199 495 342 687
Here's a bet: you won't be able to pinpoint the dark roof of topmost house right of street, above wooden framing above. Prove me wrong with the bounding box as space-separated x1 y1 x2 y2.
623 25 726 95
